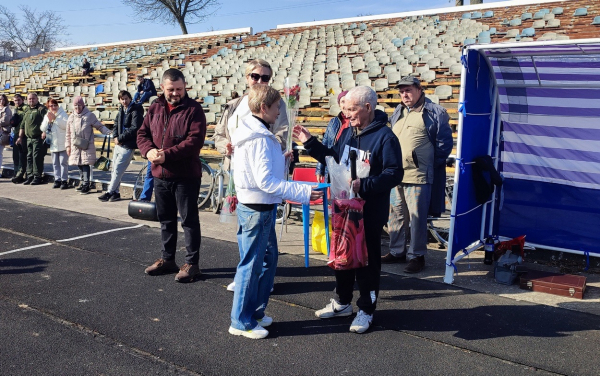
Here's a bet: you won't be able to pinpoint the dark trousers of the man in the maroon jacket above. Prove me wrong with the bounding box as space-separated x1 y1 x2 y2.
154 178 200 265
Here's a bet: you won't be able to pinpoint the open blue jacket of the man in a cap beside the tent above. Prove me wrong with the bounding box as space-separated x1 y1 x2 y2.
390 98 454 216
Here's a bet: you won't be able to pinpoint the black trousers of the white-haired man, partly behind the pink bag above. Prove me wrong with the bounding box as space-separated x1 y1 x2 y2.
335 223 383 315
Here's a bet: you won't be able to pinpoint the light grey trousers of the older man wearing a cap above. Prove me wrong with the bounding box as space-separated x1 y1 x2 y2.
388 183 431 260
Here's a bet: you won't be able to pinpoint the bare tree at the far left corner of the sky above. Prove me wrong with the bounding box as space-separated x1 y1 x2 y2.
0 5 66 52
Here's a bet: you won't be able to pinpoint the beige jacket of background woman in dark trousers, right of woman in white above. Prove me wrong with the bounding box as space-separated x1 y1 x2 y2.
65 107 111 166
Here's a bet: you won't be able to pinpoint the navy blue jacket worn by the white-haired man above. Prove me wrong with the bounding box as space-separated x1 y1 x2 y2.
304 110 404 227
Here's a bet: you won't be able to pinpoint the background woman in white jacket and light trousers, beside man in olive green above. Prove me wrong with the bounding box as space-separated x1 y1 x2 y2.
40 98 69 189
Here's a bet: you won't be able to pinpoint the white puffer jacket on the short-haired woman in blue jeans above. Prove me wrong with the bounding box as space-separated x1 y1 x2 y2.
231 116 311 204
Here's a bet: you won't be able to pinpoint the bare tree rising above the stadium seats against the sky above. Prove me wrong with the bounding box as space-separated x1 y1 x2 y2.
123 0 219 34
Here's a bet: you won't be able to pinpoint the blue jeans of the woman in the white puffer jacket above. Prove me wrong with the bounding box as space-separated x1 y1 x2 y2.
231 204 278 330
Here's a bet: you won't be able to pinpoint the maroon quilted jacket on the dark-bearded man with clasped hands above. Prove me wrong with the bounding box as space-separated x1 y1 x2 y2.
137 95 206 179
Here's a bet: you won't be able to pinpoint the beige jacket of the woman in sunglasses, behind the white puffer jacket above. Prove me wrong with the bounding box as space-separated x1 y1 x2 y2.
213 94 288 170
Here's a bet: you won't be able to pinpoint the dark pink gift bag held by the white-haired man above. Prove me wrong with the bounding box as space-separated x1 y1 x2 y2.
327 198 369 270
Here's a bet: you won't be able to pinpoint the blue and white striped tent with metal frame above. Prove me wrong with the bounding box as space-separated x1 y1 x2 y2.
444 39 600 283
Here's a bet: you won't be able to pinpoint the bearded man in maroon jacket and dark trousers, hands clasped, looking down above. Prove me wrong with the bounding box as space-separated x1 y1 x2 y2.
137 68 206 282
